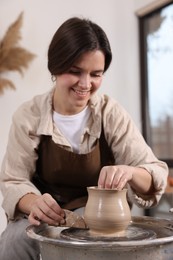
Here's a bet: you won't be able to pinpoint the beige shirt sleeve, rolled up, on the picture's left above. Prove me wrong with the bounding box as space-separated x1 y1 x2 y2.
0 104 40 219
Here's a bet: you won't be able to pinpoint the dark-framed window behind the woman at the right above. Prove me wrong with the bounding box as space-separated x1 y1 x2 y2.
139 1 173 168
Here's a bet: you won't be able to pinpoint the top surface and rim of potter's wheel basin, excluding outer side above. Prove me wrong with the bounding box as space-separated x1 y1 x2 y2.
27 217 173 248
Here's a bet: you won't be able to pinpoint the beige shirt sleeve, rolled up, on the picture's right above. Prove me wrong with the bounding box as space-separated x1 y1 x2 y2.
104 95 168 208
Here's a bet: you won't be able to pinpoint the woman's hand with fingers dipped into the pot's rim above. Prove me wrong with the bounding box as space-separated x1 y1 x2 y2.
98 165 134 190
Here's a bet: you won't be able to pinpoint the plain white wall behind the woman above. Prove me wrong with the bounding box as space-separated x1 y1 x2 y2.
0 0 157 235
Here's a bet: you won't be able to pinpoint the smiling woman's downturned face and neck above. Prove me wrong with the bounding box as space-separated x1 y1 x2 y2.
53 50 105 115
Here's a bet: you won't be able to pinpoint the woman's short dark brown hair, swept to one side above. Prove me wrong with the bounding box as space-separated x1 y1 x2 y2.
48 17 112 75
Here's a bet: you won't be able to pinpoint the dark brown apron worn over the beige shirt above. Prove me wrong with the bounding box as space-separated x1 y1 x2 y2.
33 131 115 210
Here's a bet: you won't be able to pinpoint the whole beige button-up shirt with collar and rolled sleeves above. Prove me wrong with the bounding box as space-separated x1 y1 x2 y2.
0 90 168 219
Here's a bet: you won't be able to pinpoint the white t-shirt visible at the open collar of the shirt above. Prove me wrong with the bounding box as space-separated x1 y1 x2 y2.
53 106 91 153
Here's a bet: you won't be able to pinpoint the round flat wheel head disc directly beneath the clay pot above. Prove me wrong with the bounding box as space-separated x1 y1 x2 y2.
60 223 157 242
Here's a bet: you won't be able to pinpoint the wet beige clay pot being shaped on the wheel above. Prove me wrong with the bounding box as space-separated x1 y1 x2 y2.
84 186 131 235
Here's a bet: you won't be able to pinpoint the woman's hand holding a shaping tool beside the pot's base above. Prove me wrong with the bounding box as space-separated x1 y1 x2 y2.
18 193 65 226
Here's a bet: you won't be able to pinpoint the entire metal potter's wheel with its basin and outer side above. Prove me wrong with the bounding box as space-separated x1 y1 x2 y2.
26 217 173 260
